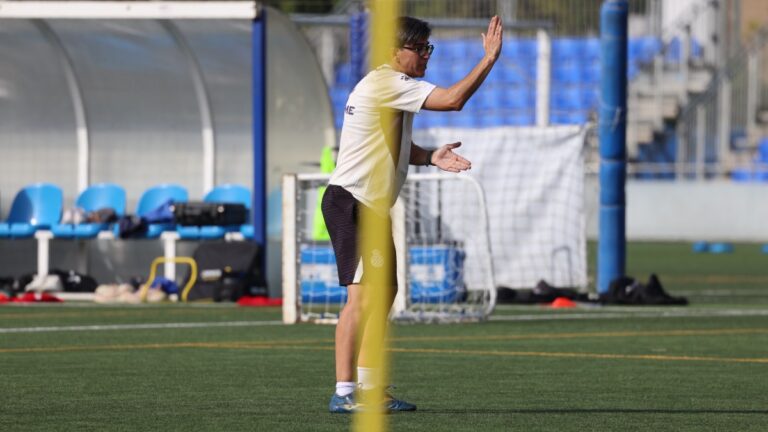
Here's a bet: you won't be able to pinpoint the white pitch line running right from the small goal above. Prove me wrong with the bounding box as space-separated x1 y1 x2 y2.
490 309 768 321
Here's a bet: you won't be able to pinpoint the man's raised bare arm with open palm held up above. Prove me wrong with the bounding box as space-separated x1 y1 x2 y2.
424 16 504 111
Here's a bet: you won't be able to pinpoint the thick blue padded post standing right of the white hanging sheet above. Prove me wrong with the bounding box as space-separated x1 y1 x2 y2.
597 0 628 294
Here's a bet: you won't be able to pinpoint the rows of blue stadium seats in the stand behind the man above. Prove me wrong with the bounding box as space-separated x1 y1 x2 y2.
330 36 702 129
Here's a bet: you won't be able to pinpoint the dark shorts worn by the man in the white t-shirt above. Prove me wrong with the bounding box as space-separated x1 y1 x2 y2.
322 185 397 286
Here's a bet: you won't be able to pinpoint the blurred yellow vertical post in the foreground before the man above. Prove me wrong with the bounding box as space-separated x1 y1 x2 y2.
352 0 400 432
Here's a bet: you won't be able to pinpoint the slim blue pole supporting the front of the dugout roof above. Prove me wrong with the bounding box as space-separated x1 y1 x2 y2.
251 8 267 248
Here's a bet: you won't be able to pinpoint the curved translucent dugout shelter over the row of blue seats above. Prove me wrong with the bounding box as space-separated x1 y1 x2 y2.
0 1 335 292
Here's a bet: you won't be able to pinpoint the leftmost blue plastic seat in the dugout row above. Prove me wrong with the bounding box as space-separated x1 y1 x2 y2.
0 183 64 238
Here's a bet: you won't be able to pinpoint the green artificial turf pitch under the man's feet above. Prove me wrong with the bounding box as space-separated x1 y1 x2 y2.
0 244 768 432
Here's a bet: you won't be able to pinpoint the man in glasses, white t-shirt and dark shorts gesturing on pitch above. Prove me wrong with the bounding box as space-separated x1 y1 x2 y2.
322 16 503 413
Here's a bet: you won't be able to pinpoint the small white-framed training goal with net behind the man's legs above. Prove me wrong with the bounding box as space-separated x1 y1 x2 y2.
282 173 496 323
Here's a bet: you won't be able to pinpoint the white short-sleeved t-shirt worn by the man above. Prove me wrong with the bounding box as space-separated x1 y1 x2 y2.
329 65 435 214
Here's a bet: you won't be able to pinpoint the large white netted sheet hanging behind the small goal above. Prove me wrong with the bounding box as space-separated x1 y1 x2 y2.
413 125 591 289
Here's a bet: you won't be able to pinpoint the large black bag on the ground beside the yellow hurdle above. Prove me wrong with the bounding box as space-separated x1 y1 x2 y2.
185 241 267 302
